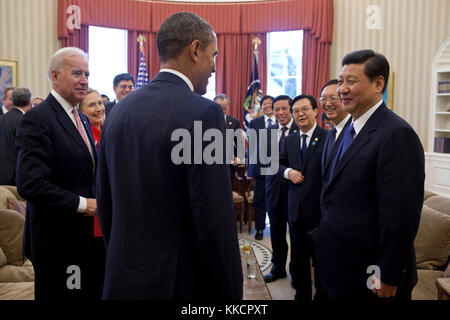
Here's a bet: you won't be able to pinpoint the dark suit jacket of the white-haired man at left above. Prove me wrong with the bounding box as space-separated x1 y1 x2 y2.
16 94 97 296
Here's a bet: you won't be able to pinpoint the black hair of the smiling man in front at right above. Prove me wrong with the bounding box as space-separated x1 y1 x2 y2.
342 49 389 93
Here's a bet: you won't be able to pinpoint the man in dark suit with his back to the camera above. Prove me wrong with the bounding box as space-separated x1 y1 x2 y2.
97 12 243 300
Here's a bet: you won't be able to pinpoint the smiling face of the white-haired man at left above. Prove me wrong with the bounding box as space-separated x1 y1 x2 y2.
51 55 89 106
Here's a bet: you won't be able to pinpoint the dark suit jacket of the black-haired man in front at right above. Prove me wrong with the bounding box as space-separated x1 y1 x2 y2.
318 103 425 298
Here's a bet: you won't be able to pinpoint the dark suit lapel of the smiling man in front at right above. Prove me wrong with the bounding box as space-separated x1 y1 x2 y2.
327 103 388 187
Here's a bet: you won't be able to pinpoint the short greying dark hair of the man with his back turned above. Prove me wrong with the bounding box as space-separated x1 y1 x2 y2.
156 12 214 62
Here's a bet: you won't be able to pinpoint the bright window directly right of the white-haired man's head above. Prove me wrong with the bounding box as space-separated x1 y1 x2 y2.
89 26 128 101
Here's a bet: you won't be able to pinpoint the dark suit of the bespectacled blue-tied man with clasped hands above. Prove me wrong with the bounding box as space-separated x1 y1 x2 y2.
280 126 327 300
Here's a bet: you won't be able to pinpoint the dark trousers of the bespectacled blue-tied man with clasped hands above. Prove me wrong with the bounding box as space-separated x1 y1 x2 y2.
289 220 327 301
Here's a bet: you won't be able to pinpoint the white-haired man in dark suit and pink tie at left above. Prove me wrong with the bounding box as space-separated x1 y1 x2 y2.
16 47 104 300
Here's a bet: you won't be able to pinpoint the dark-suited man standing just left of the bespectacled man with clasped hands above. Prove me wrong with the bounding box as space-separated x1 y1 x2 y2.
264 95 298 282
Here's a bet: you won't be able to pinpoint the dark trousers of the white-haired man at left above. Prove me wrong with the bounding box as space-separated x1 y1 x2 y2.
33 237 106 300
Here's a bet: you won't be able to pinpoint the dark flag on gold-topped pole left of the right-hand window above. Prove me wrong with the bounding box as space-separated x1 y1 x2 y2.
244 37 262 130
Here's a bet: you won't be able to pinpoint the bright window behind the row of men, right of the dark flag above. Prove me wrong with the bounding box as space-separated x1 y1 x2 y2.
267 30 303 98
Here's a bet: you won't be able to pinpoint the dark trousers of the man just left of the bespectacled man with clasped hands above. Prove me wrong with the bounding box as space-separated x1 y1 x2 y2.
269 197 288 274
